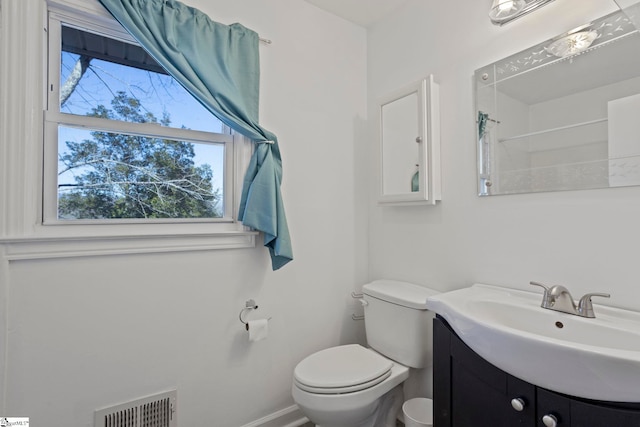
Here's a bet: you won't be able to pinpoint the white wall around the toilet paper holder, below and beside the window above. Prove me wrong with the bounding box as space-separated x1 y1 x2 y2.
0 0 368 427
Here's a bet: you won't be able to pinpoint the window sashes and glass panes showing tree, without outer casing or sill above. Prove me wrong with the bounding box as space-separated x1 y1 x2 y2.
43 12 238 224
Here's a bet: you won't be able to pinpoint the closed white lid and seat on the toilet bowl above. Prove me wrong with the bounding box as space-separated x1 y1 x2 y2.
293 344 393 393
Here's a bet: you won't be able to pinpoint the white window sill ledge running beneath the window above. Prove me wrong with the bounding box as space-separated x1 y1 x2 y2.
0 230 258 261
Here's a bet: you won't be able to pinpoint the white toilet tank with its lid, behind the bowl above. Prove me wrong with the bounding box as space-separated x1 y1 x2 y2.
362 280 437 368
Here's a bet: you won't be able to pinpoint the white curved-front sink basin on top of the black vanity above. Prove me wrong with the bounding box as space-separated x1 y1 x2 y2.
427 284 640 402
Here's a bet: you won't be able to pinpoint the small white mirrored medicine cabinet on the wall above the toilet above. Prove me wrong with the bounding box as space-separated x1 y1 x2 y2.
378 76 441 205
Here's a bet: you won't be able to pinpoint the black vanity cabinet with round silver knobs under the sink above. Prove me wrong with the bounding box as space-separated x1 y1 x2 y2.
433 316 640 427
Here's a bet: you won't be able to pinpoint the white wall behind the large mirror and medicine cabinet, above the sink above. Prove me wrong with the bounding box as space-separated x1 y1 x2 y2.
368 0 640 309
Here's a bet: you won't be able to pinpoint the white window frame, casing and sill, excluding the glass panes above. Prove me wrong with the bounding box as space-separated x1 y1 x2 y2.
0 0 257 260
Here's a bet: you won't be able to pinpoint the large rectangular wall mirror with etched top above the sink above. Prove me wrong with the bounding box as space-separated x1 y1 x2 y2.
474 8 640 196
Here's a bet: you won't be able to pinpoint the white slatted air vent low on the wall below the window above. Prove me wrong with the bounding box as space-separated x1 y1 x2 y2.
94 390 178 427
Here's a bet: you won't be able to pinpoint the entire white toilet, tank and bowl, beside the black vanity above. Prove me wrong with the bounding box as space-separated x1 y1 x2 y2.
292 280 436 427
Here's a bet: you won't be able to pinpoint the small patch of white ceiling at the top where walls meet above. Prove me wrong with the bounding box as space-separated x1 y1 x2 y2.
305 0 408 27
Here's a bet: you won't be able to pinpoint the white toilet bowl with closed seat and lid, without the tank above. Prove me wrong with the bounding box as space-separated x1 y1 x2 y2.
292 344 409 427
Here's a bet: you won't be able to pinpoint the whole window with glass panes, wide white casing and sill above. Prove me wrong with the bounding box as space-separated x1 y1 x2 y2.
0 0 258 260
